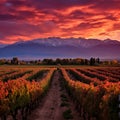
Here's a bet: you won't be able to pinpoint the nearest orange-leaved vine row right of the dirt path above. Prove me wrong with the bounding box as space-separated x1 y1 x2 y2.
61 68 120 120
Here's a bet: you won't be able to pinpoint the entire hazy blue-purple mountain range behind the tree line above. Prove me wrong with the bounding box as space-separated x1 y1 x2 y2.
0 37 120 59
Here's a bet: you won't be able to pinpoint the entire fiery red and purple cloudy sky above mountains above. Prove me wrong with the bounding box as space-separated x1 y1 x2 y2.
0 0 120 43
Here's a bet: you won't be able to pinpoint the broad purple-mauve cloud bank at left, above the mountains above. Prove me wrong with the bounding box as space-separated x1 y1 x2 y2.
0 21 57 40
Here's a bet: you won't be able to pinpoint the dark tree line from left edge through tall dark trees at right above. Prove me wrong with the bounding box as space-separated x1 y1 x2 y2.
0 57 100 65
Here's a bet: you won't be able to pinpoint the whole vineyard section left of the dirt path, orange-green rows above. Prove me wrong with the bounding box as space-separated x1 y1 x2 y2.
0 68 55 120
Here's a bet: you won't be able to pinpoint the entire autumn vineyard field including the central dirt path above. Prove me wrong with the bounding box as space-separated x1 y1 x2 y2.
0 65 120 120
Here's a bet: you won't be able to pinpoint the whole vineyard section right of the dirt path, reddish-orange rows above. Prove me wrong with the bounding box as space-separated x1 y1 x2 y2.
61 68 120 120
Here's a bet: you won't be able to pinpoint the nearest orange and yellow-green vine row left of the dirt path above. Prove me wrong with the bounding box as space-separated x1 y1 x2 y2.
0 68 55 119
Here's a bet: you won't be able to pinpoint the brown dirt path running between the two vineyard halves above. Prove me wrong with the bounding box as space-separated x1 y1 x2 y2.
28 71 81 120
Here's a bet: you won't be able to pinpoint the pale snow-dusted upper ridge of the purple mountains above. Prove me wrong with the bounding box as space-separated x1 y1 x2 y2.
22 37 120 48
